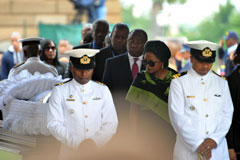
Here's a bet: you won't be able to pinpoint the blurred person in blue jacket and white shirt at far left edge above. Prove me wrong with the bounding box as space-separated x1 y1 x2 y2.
1 32 24 79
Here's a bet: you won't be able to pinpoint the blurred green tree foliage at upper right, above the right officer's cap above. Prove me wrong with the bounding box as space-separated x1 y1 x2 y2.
180 0 240 43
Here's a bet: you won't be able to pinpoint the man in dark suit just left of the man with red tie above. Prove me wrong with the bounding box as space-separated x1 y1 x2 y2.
92 23 129 81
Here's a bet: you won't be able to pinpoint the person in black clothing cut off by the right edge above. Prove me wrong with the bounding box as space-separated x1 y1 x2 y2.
226 43 240 160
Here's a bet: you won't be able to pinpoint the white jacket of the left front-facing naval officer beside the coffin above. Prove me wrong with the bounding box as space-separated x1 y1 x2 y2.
47 79 118 149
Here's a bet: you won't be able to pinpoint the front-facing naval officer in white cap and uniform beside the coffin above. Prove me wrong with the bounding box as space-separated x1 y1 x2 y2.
47 49 118 159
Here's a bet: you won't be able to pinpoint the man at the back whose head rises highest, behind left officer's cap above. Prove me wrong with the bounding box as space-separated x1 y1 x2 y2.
73 19 109 49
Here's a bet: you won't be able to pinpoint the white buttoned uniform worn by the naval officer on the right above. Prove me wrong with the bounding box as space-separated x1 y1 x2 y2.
168 68 233 160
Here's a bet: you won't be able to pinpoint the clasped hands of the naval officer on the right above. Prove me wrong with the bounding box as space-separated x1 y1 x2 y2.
197 138 217 160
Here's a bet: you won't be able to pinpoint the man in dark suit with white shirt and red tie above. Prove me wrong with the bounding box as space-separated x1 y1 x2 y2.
103 29 147 136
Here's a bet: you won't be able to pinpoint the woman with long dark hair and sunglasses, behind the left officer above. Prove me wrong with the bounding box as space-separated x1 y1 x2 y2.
40 39 68 78
